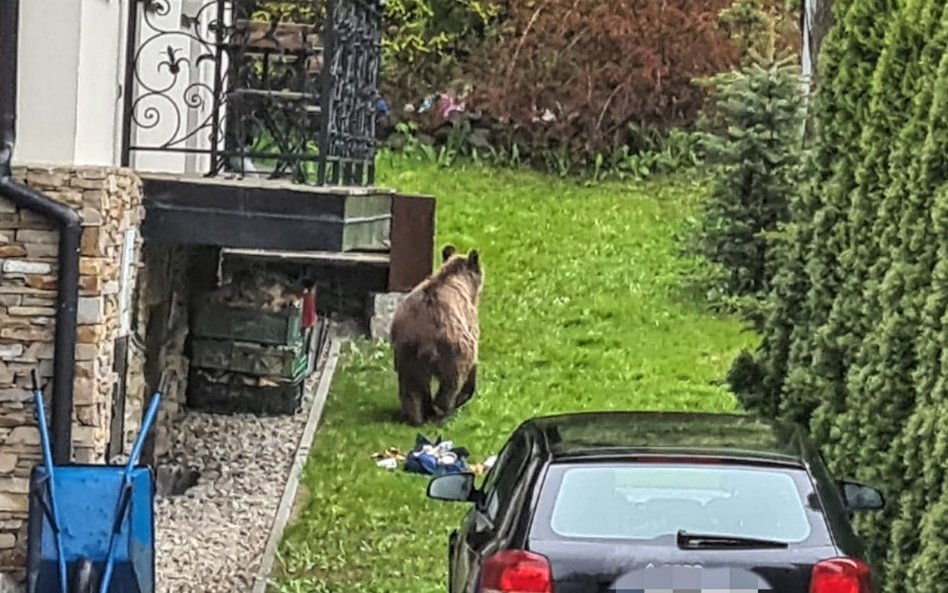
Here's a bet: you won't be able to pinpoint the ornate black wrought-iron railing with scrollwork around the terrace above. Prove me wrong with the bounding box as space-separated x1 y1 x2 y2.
123 0 382 185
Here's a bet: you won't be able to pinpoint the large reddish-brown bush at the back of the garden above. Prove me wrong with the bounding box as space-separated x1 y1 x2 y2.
472 0 738 162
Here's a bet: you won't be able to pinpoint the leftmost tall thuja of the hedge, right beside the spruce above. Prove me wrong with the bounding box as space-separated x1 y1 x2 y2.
729 0 871 430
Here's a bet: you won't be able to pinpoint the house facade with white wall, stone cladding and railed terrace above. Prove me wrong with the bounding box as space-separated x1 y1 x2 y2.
0 0 434 582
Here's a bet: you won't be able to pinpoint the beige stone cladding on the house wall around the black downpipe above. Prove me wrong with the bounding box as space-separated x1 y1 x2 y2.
0 167 143 576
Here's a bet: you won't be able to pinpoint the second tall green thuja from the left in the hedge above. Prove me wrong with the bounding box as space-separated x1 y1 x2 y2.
785 0 893 440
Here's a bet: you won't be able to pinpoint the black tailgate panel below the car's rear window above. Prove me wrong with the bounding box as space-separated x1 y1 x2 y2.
530 540 838 593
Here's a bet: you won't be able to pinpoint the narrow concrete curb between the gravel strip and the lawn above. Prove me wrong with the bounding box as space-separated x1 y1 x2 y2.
251 335 344 593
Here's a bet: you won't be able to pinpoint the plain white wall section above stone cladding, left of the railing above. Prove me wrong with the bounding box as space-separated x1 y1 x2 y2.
14 0 129 165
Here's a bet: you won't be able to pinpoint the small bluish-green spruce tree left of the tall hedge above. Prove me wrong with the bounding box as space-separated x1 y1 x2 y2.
697 0 804 301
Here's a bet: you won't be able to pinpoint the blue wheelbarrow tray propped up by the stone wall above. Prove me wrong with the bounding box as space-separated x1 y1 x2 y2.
27 465 155 593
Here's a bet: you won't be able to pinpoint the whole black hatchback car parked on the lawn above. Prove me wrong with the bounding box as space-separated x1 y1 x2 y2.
428 412 883 593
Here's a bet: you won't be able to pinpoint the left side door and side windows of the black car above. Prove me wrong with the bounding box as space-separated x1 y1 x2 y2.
449 434 529 593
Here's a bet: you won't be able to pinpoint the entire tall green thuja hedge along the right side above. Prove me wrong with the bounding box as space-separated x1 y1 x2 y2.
730 0 948 593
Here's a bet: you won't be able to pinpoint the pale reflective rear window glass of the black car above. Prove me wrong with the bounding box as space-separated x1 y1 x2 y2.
550 464 811 543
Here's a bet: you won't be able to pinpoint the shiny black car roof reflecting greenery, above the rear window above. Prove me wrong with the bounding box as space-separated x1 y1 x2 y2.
518 411 818 466
